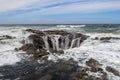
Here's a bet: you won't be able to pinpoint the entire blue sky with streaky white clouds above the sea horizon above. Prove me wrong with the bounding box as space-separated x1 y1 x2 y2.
0 0 120 24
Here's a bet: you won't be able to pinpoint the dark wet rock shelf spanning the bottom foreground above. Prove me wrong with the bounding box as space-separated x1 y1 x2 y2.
0 59 108 80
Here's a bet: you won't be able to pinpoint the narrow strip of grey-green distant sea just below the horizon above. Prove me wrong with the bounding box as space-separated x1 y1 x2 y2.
0 24 120 34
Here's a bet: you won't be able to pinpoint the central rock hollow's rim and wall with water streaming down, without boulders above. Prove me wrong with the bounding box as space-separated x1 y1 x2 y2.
26 29 88 50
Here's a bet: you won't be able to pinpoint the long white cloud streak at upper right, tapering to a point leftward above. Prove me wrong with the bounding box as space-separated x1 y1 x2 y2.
38 0 120 15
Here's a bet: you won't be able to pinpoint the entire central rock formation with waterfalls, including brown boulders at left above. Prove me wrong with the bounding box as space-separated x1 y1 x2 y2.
20 29 88 57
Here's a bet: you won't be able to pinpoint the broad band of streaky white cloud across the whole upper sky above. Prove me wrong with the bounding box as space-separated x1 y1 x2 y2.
0 0 120 16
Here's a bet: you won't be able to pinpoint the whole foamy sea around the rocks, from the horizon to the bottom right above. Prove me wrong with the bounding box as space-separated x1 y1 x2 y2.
0 24 120 80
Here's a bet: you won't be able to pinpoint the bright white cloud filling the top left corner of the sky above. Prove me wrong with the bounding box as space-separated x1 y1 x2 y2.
0 0 38 12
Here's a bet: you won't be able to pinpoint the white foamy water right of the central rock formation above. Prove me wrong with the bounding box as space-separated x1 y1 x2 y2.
48 34 120 80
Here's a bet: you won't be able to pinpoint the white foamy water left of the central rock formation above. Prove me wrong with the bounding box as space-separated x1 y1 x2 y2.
0 28 30 66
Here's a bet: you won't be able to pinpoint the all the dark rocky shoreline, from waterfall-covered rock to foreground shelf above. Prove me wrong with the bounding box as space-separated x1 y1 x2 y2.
0 29 120 80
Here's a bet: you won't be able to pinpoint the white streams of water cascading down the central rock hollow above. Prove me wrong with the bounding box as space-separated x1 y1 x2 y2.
42 35 81 50
